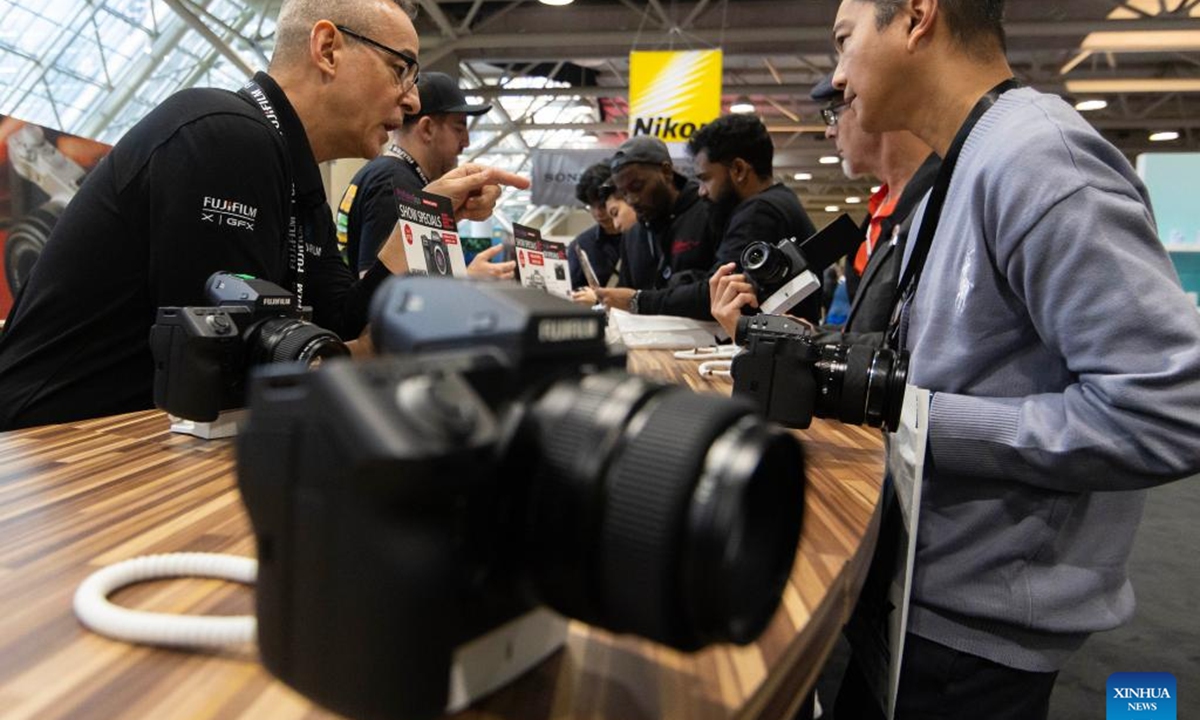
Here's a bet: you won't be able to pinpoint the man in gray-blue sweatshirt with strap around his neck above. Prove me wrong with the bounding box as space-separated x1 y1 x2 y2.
834 0 1200 720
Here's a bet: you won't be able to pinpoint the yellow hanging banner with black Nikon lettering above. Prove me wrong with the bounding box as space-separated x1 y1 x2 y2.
629 50 724 143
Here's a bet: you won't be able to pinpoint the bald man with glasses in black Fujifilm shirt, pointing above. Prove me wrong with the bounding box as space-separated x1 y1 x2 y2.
0 0 527 430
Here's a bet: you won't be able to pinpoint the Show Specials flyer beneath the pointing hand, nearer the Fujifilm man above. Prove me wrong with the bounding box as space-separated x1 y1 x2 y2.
396 188 467 277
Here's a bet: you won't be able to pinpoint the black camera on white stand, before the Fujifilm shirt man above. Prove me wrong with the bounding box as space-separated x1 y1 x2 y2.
150 272 349 422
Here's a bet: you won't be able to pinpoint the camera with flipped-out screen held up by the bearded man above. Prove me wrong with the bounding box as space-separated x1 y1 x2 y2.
742 214 863 314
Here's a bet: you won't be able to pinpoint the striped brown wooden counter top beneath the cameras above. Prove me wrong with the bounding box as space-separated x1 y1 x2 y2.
0 352 882 720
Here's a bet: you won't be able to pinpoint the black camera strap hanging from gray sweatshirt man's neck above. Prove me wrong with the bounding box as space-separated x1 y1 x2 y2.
886 78 1021 350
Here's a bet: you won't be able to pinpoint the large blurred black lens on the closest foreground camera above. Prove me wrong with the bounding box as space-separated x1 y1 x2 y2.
520 373 804 650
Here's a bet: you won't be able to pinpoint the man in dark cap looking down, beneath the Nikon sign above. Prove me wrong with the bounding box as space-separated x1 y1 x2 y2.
605 136 716 304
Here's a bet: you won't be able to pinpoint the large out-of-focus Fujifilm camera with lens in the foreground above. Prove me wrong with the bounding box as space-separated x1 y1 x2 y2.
238 276 804 719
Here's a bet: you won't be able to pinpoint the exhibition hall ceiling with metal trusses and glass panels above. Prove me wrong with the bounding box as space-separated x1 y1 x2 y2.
0 0 1200 215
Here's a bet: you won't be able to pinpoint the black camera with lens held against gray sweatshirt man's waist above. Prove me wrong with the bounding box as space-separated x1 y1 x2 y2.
730 314 908 431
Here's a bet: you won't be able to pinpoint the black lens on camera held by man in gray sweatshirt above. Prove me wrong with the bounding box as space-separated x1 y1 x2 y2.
812 343 908 430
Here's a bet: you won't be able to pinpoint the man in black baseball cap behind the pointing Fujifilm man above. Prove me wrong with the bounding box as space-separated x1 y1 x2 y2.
337 72 512 277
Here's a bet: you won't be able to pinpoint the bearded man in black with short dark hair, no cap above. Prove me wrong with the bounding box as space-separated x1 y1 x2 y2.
604 115 821 322
